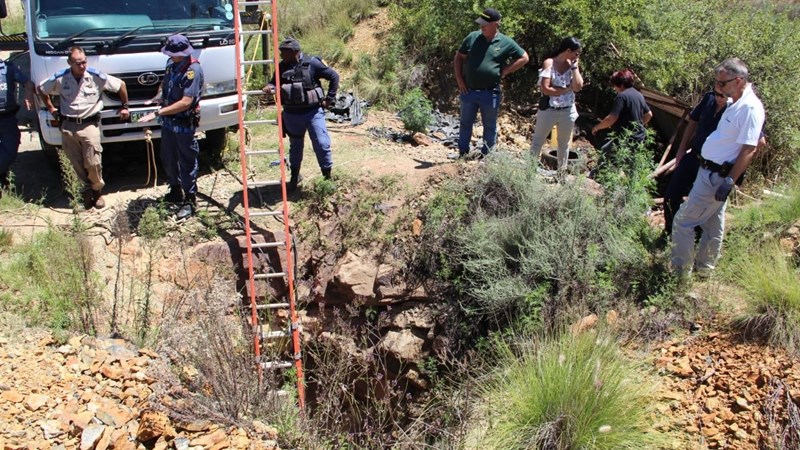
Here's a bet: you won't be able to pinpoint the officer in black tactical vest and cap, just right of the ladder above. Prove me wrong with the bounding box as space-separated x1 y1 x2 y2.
264 38 339 191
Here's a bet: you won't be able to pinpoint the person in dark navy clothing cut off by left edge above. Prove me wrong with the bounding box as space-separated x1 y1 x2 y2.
0 59 34 197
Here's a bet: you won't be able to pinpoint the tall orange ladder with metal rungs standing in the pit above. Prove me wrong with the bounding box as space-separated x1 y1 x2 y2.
234 0 305 410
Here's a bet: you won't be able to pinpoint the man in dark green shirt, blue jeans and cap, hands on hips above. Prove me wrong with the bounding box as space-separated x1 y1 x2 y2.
453 8 528 157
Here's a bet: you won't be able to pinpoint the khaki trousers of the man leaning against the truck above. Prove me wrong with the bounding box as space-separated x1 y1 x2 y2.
61 120 106 191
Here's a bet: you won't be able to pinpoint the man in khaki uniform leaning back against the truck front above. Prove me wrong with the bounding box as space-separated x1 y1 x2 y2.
39 46 130 209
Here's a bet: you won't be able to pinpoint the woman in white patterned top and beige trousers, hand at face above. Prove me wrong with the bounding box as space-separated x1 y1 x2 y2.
531 37 583 170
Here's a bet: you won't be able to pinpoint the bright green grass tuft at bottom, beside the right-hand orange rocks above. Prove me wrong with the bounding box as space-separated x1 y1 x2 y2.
466 332 659 450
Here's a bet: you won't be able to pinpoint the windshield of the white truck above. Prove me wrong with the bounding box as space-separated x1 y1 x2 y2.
30 0 234 40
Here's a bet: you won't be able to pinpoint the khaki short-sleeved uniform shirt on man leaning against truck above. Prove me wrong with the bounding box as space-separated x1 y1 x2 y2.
39 67 122 119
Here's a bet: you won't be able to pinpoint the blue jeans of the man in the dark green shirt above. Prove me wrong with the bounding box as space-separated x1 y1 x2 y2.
458 88 502 155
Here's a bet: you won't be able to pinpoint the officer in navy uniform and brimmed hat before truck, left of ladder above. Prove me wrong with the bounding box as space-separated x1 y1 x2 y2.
140 34 203 219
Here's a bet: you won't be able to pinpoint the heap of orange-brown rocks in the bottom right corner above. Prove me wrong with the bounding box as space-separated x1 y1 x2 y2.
655 327 800 449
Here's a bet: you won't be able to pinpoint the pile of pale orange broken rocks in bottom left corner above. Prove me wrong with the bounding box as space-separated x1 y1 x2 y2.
0 332 278 450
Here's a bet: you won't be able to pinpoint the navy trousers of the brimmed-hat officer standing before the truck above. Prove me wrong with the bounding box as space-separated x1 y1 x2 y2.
161 126 200 195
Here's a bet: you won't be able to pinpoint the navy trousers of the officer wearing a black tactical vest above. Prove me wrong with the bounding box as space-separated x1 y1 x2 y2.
283 108 333 169
